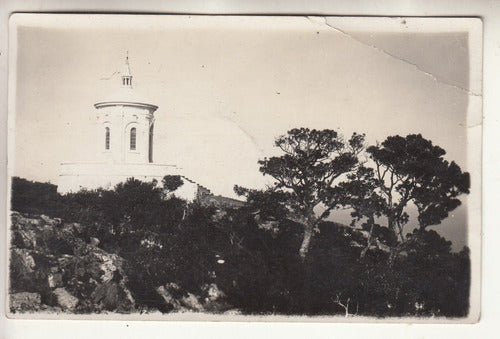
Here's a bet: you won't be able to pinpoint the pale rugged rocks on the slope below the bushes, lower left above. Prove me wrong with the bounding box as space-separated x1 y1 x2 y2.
9 212 227 313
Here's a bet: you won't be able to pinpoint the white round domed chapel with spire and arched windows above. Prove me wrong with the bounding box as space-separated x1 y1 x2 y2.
57 55 210 200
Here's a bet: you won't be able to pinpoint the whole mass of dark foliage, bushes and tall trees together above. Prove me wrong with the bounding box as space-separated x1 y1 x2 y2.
11 129 470 317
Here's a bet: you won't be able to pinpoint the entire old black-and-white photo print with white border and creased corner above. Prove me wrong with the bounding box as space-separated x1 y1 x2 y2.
6 14 482 323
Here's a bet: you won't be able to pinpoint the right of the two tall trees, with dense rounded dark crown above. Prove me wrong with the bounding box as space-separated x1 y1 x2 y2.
367 134 470 241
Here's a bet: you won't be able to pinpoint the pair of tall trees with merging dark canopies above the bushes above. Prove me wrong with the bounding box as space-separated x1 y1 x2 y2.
236 128 470 258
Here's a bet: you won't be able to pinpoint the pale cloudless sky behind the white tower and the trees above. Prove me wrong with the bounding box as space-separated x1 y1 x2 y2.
9 15 477 249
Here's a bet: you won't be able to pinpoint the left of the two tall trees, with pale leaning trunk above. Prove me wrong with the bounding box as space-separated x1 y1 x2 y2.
236 128 364 258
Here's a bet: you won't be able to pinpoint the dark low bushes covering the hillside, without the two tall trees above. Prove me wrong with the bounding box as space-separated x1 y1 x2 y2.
11 178 470 317
